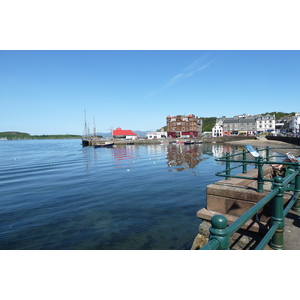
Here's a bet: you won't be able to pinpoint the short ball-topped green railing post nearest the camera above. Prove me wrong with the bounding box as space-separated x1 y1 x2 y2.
209 215 230 250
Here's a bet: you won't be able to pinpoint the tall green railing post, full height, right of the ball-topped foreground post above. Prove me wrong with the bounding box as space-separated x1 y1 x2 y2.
270 176 285 250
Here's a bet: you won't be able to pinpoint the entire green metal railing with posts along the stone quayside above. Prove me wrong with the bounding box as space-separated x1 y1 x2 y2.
200 147 300 250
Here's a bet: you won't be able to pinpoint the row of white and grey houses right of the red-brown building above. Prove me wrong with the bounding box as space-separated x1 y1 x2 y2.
212 113 300 137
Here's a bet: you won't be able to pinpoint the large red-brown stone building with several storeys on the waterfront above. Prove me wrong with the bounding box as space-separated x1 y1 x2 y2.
167 114 202 138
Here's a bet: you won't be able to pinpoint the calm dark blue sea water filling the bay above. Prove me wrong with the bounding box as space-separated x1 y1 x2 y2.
0 140 244 250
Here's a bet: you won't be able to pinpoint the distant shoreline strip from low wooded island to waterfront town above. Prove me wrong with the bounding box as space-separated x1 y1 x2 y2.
0 112 300 140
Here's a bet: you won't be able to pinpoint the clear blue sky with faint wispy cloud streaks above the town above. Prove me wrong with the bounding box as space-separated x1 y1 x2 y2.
0 50 300 134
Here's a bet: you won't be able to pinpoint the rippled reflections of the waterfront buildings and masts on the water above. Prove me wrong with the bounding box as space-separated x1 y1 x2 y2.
83 144 242 176
